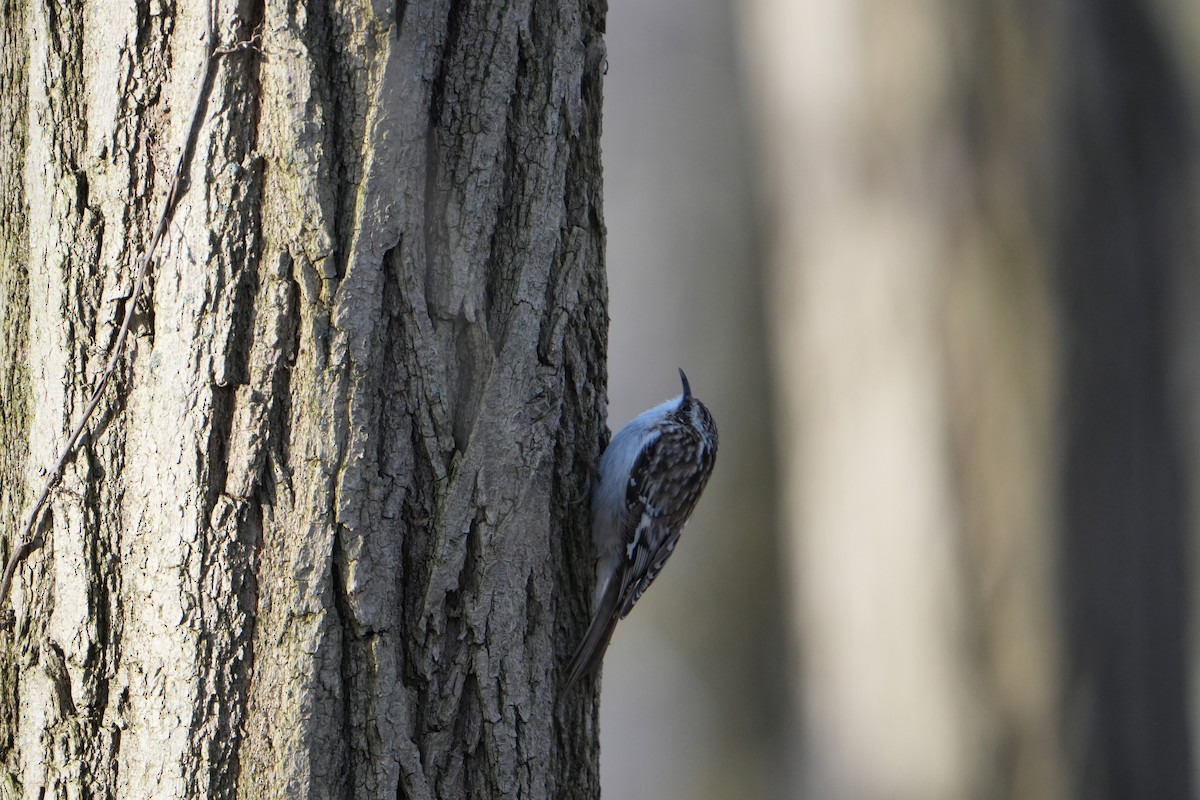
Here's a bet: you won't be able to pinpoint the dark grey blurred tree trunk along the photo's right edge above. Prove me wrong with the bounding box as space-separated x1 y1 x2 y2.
1055 0 1200 800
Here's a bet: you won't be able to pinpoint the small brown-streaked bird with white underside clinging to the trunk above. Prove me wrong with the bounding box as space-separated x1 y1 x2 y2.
564 369 718 692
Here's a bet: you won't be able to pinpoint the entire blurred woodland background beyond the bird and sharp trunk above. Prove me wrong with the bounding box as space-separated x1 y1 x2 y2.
601 0 1200 800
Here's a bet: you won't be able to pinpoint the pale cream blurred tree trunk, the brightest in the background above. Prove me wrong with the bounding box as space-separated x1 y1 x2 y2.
750 0 992 800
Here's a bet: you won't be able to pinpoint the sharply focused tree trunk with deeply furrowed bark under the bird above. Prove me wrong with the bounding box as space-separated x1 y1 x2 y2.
0 0 607 798
